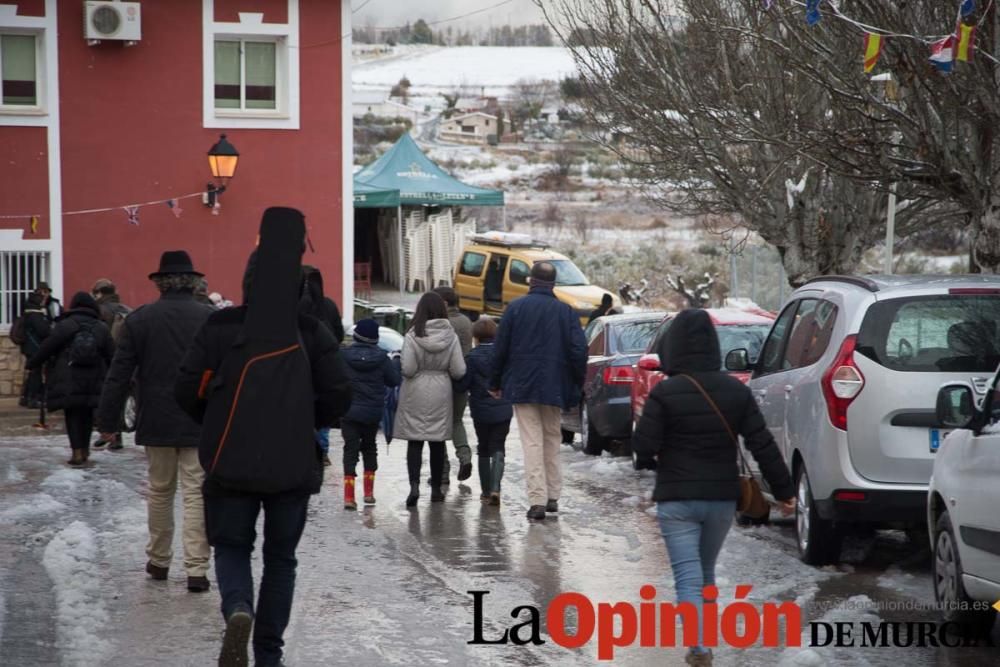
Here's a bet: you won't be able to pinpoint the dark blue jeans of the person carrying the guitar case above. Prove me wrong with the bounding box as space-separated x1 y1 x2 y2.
205 495 309 665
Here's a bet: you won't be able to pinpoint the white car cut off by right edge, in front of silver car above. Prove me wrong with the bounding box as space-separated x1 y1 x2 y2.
927 374 1000 634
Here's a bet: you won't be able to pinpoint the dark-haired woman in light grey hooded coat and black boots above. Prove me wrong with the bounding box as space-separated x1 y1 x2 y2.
393 292 465 507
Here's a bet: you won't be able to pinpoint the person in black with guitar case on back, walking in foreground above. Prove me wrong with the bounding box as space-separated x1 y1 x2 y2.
176 208 350 665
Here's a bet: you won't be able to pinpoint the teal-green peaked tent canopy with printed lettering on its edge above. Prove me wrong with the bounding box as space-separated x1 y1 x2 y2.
354 134 504 207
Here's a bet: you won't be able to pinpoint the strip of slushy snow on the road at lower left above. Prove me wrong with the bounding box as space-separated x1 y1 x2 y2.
42 521 111 665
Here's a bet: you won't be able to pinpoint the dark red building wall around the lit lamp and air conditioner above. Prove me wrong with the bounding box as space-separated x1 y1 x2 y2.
55 0 343 305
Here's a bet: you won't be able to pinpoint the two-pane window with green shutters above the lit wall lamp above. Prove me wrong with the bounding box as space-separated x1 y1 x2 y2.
213 35 288 115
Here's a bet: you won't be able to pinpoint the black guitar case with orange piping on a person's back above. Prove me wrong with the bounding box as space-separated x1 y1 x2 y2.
198 208 323 494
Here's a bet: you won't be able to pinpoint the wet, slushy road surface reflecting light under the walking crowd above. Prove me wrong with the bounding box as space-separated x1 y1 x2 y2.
0 416 1000 667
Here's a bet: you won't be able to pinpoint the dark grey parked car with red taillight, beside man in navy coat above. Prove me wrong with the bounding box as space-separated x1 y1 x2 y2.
562 311 666 456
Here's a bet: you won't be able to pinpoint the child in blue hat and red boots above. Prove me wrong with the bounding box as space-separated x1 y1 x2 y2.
340 320 400 510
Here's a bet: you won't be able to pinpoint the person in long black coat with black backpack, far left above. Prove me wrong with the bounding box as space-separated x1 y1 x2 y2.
27 292 115 466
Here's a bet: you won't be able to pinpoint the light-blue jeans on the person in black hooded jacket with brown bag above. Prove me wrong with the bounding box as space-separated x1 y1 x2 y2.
656 500 736 652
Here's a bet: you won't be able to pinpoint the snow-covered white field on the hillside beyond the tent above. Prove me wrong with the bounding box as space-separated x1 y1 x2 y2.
352 46 576 96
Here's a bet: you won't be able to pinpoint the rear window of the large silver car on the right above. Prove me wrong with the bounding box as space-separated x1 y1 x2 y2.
857 294 1000 373
